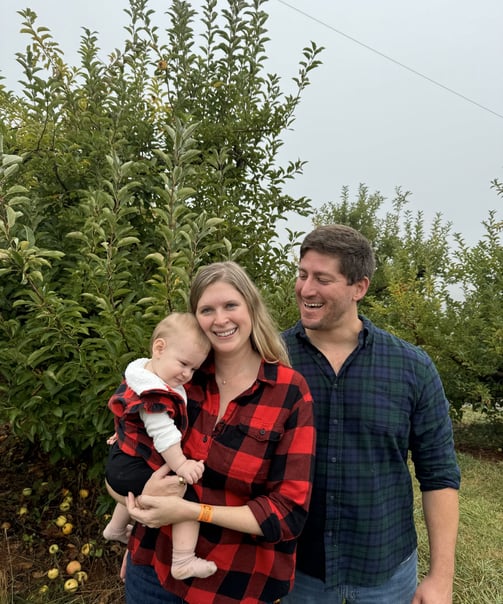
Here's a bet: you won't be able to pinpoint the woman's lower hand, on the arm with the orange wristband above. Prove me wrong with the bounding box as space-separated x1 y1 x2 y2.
126 493 189 528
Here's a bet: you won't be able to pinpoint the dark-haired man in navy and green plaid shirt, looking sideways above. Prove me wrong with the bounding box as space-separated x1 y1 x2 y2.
282 225 460 604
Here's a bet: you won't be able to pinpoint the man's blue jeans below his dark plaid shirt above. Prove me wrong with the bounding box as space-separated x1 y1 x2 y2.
281 550 417 604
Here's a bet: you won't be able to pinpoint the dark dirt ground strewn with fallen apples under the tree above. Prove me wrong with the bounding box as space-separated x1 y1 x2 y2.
0 425 125 604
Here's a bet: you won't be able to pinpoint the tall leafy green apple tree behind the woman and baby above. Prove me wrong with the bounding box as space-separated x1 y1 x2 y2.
0 0 321 459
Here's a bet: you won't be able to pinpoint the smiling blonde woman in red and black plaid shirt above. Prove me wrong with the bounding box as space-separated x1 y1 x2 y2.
122 262 315 604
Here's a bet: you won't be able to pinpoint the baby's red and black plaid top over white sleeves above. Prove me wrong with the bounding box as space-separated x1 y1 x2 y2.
108 380 188 470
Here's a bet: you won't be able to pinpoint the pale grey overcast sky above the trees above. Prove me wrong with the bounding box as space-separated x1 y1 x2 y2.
0 0 503 244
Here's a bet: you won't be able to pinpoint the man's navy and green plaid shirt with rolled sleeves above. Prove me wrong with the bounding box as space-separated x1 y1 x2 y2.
283 317 460 587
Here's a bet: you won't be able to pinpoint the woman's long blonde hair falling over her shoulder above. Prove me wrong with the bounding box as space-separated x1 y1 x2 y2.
189 261 290 366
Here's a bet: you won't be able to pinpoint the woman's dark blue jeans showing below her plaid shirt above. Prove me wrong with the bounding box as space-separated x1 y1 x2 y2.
125 554 183 604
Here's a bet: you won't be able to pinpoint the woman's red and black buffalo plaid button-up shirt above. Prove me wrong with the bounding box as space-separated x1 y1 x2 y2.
129 363 315 604
